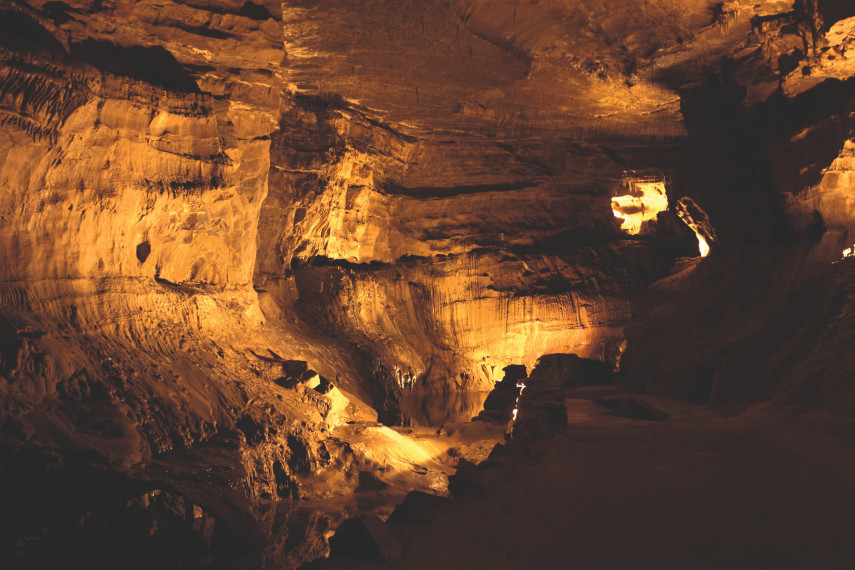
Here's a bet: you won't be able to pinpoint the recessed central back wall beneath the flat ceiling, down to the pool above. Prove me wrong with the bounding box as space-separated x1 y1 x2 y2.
256 98 691 390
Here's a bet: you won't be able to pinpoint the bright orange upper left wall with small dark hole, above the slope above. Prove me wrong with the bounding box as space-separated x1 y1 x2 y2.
0 3 281 285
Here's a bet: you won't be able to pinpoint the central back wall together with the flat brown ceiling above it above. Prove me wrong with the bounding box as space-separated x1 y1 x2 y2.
256 0 711 393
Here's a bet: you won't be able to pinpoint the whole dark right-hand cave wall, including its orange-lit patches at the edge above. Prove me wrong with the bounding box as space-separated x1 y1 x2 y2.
626 2 855 408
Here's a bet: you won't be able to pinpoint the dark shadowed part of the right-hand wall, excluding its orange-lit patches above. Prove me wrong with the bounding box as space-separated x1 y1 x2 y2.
626 56 855 410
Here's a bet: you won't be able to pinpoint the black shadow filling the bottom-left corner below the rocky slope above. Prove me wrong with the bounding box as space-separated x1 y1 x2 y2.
0 447 257 569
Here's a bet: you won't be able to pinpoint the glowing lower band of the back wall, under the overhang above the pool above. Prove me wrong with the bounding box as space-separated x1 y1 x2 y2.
280 245 668 389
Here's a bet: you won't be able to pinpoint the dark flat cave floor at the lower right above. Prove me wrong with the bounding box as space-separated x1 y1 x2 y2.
309 392 855 569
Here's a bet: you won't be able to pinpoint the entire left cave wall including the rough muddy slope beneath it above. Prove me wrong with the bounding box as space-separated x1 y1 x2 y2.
0 2 376 567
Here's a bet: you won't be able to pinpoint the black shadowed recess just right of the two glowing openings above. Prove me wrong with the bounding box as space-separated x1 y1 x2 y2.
682 77 855 244
